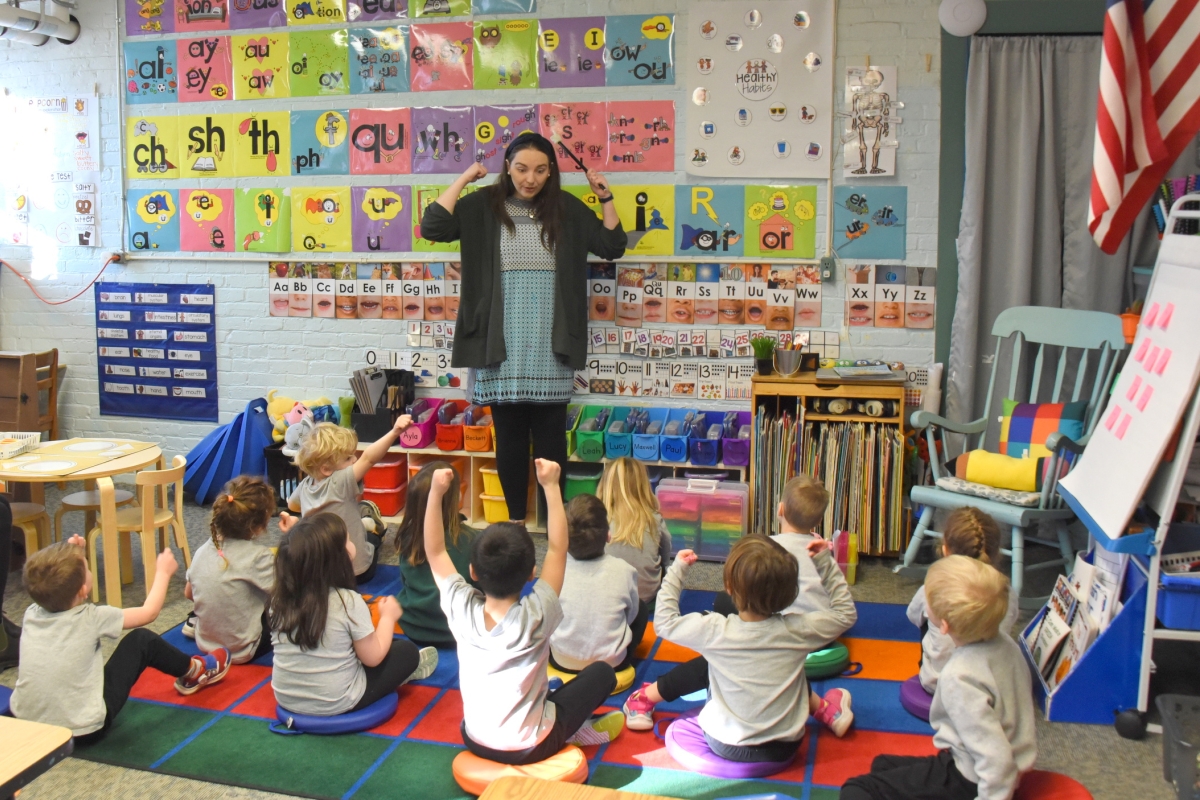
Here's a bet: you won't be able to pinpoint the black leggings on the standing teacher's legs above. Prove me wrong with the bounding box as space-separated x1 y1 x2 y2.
492 403 566 519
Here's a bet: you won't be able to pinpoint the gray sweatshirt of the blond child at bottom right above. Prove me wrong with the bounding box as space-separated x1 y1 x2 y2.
929 633 1038 800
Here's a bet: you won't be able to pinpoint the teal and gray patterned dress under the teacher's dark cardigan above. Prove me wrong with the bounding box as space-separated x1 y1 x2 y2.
473 198 575 404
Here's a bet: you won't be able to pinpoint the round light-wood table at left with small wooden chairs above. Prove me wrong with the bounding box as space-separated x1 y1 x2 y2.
0 438 166 608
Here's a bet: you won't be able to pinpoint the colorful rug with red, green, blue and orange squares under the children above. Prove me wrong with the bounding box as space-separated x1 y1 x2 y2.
74 566 935 800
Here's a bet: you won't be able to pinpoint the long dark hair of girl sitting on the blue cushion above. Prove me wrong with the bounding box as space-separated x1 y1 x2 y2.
269 511 355 650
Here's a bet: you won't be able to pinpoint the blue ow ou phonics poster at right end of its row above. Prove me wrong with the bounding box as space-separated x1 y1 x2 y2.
605 14 674 86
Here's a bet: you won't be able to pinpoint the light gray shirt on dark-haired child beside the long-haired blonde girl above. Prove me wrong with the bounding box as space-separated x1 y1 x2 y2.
550 555 637 669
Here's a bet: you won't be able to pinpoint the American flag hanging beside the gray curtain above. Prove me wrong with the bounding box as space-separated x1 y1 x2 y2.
1087 0 1200 253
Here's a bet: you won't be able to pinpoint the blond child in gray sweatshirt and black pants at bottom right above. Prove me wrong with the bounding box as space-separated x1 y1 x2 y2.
840 555 1038 800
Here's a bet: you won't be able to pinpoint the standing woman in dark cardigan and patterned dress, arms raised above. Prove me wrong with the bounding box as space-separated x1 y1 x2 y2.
421 133 626 522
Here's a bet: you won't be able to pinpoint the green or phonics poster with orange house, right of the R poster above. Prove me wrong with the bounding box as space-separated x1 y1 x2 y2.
744 186 817 258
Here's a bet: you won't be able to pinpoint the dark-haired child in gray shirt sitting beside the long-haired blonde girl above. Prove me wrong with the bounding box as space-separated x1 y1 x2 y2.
550 494 650 673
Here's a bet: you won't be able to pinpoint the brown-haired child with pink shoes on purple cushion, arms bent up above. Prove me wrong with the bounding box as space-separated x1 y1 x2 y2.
624 535 858 762
